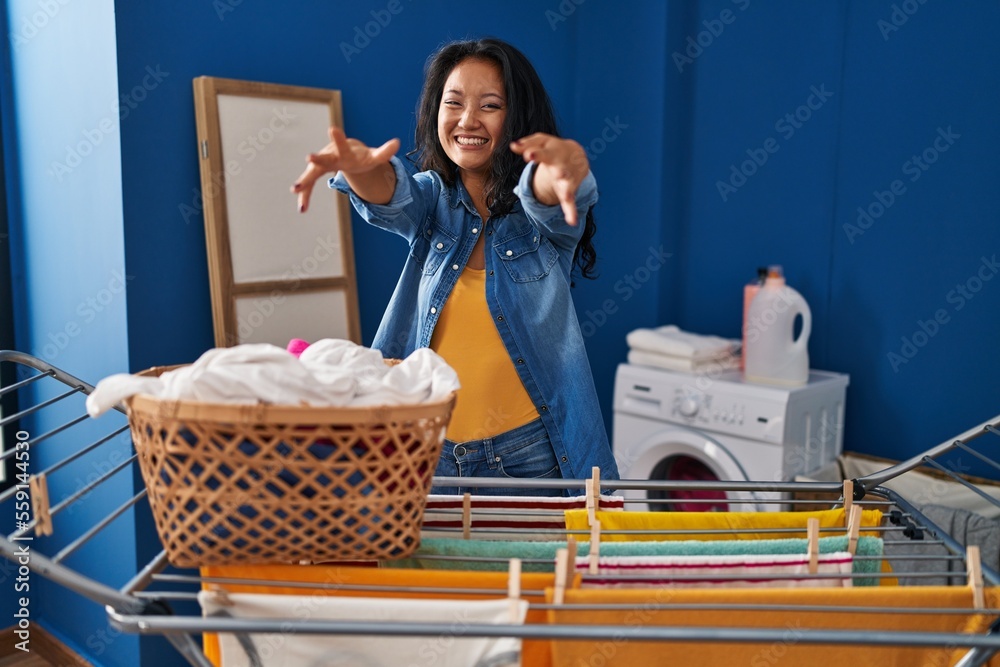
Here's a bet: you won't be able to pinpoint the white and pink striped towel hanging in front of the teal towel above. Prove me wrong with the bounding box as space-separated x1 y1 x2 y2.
576 551 854 588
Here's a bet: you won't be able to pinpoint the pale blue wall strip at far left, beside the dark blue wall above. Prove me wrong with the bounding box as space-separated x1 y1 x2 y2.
2 0 138 667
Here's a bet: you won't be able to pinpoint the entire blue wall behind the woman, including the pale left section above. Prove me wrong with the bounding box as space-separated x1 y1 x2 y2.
5 0 1000 665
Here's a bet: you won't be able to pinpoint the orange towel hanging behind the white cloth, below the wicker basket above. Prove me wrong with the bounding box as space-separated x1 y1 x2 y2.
201 565 579 667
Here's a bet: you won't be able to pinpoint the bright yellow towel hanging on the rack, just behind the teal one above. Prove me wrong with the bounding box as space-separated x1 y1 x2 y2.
565 508 882 542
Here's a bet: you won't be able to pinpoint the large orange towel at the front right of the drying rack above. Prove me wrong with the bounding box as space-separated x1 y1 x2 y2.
548 586 1000 667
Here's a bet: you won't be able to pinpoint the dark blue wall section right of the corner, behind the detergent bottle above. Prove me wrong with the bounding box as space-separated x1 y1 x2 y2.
664 0 1000 468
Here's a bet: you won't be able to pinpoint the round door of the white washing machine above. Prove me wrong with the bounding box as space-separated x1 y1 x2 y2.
618 425 757 512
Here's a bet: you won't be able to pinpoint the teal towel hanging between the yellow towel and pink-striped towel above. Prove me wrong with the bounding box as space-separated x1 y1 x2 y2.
382 535 883 586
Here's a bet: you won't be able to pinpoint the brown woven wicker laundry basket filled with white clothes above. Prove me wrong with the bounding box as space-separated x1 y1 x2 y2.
126 367 455 567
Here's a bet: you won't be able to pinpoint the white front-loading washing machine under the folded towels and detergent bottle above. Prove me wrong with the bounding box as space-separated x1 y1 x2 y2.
612 364 849 511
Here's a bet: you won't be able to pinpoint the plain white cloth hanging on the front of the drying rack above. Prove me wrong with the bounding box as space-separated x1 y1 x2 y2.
198 591 528 667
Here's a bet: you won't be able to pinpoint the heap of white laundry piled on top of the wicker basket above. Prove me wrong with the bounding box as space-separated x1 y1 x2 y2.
87 339 459 417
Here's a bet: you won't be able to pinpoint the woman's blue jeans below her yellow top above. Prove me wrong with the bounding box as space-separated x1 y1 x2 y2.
431 419 565 496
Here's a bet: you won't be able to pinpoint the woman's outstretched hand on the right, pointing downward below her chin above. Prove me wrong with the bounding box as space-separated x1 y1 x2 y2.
510 132 590 225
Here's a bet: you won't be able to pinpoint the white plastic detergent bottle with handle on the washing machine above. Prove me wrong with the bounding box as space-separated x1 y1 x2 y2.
743 266 812 386
